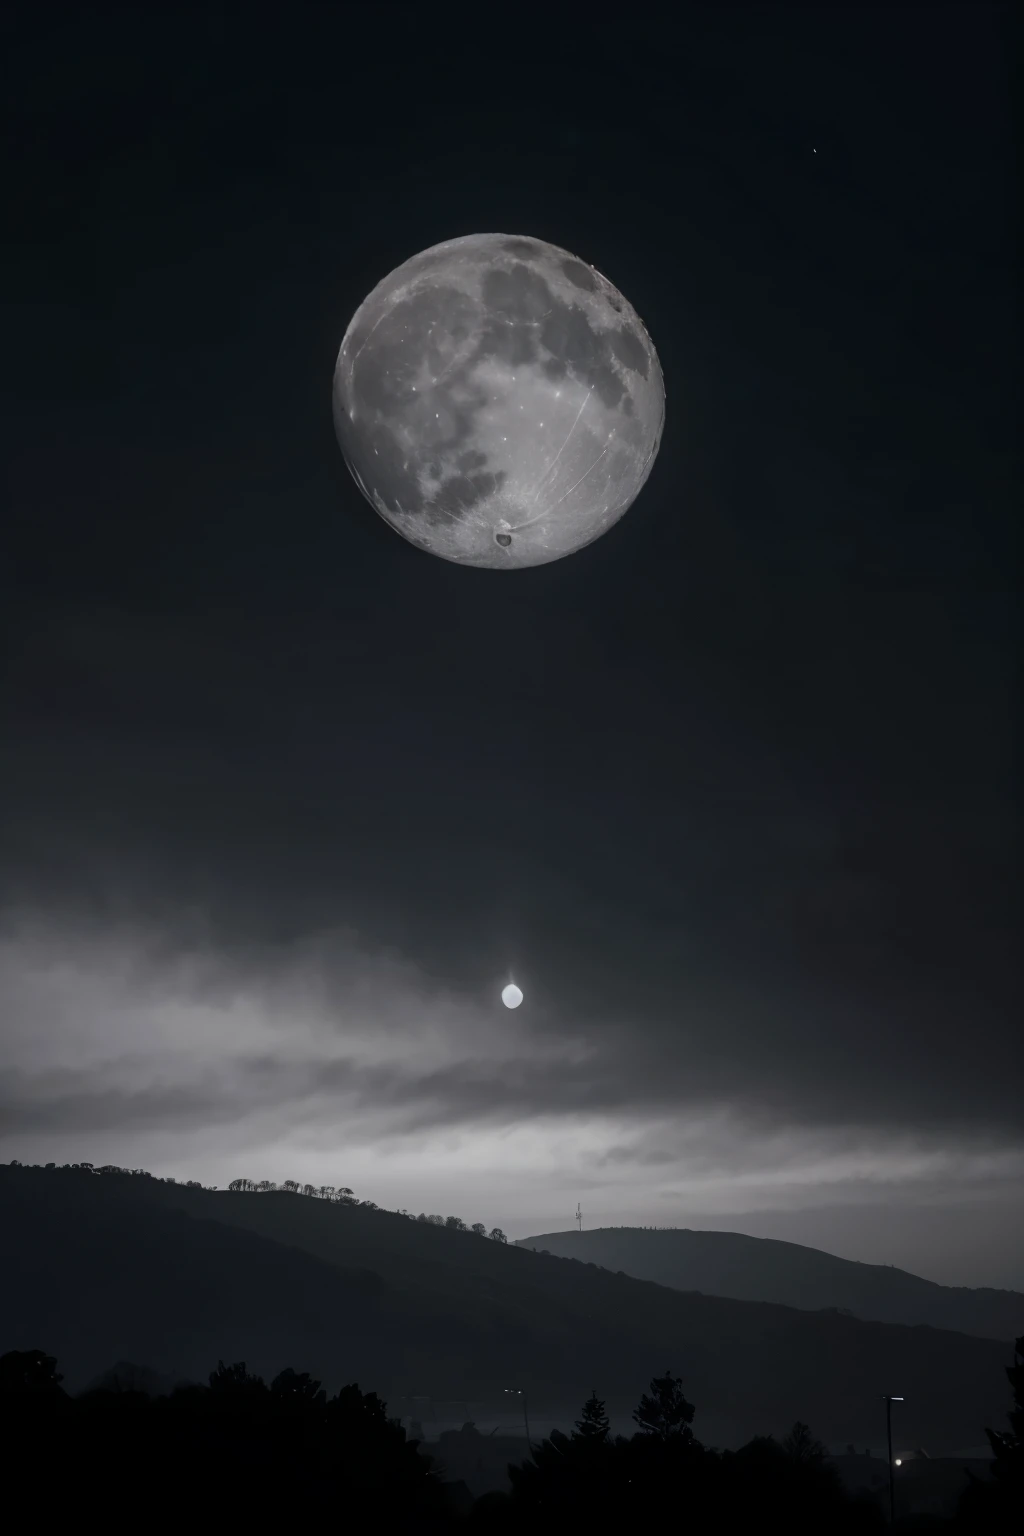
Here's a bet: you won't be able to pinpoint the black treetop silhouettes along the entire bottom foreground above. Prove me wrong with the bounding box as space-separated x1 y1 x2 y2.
0 1338 1024 1533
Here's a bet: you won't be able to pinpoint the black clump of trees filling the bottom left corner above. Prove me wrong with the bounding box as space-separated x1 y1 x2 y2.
0 1350 471 1536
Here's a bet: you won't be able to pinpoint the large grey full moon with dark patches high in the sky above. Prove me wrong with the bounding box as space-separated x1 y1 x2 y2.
335 235 665 570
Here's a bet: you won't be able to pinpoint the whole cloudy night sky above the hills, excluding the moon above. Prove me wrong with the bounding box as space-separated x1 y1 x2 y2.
0 3 1024 1287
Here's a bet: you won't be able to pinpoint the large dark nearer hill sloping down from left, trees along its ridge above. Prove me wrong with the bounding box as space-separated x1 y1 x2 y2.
0 1167 1006 1455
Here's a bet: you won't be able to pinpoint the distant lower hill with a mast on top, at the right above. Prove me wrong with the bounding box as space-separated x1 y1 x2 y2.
517 1227 1024 1339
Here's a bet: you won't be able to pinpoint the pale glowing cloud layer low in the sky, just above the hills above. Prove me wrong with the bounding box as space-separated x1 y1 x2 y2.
0 912 1024 1290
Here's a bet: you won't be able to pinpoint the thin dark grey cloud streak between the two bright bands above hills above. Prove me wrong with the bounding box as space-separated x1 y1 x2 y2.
0 1007 1019 1167
